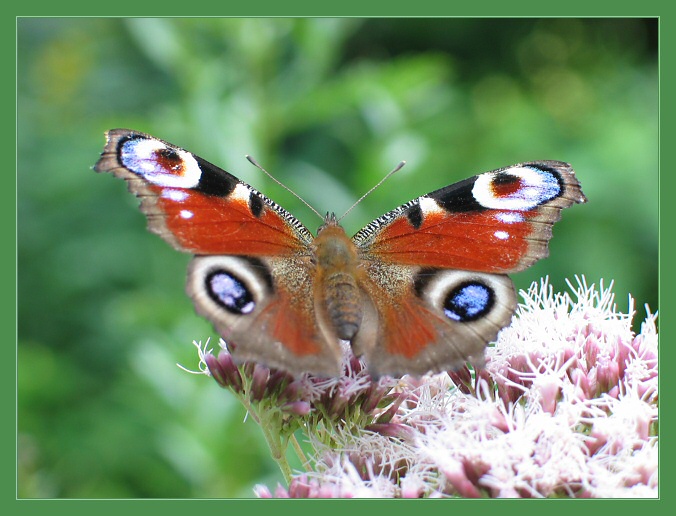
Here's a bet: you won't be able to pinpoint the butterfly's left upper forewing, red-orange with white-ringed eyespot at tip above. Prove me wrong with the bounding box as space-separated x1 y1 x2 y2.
94 129 313 256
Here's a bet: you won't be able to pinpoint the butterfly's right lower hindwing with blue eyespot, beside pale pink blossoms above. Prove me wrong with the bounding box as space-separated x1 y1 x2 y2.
353 263 516 376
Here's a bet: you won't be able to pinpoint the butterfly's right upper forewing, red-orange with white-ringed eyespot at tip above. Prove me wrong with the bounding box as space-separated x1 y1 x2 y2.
353 161 586 273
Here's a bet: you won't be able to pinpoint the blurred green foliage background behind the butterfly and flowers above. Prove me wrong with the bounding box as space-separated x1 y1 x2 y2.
18 18 658 498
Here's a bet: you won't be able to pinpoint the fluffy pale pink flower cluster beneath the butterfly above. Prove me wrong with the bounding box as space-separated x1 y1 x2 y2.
193 279 658 498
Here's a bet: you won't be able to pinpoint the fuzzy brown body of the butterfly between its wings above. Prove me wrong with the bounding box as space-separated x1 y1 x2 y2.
313 217 363 340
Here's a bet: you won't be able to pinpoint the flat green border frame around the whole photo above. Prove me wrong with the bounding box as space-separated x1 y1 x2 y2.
9 0 664 515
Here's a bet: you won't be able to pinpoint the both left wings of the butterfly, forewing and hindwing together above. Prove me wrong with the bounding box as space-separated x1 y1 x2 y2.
95 129 342 376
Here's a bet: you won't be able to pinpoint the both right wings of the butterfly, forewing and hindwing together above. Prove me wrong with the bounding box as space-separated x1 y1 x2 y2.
353 161 586 374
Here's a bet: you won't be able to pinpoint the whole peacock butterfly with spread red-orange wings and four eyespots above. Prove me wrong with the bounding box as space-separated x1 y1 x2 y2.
94 129 586 376
